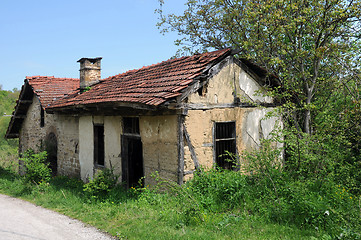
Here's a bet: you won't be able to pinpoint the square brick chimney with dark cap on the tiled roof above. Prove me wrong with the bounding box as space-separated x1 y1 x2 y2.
78 57 102 90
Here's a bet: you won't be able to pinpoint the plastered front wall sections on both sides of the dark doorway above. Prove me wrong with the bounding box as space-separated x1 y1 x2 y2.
79 115 178 184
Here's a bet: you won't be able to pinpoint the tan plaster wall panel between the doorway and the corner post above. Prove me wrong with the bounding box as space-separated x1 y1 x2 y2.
139 115 178 184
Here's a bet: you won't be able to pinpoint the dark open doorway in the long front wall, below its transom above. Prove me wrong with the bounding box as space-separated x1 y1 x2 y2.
122 135 144 188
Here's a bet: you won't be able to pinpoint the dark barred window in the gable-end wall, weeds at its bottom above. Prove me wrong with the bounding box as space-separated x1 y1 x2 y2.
215 122 237 170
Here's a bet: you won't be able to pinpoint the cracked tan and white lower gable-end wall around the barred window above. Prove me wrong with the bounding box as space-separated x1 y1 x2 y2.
184 107 282 174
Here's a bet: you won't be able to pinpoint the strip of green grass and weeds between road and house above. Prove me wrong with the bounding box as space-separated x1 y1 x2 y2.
0 165 352 239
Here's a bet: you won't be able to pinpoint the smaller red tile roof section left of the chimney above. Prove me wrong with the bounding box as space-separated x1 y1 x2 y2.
25 76 79 108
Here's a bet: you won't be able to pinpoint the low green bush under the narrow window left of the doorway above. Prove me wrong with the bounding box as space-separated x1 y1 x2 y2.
83 168 119 199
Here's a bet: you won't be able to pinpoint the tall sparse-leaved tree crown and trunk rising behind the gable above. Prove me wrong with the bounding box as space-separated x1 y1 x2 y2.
157 0 361 134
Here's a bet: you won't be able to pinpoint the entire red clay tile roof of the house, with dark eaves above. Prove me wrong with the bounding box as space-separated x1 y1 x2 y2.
6 48 278 138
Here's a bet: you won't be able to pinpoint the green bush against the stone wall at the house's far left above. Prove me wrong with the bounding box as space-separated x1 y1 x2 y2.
20 149 51 184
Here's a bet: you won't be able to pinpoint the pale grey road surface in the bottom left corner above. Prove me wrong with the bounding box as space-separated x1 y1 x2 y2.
0 194 114 240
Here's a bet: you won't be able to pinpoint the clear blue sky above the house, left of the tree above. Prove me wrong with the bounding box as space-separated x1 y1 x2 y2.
0 0 186 90
